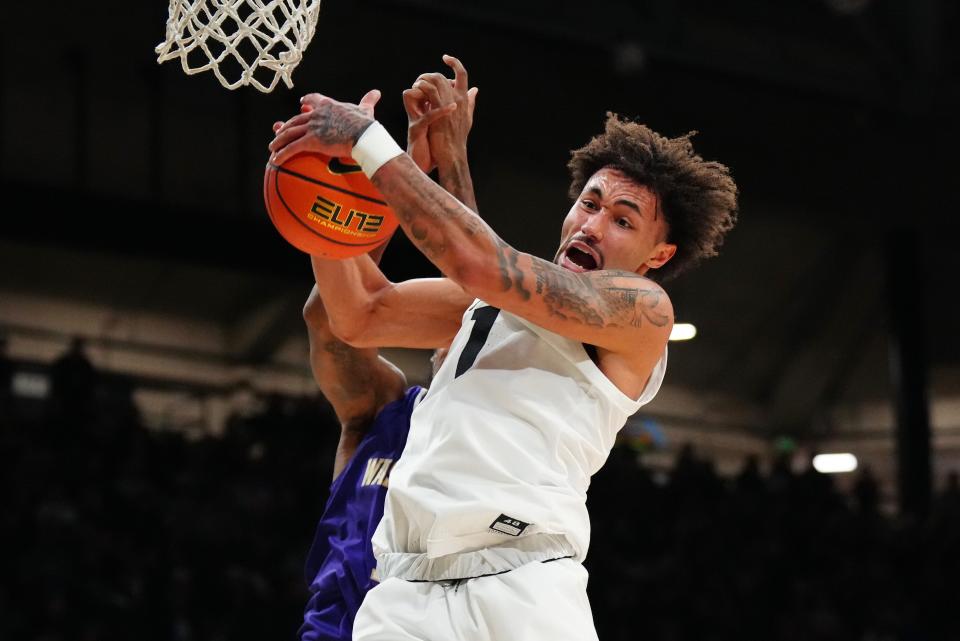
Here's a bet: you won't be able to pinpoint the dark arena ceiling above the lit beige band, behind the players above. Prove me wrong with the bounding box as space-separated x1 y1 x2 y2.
0 0 960 436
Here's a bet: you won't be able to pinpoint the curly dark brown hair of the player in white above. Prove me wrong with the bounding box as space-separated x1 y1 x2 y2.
567 112 737 281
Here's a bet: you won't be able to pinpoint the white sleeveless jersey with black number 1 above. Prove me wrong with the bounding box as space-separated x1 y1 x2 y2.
373 300 667 581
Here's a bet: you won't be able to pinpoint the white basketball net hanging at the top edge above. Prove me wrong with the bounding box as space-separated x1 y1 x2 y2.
156 0 320 93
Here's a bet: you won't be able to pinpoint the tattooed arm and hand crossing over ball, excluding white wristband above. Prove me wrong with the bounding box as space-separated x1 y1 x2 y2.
270 94 673 364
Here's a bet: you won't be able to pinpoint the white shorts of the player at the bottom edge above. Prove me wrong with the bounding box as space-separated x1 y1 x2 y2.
353 559 597 641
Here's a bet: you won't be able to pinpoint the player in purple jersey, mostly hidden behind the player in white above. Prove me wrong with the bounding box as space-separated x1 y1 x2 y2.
288 61 477 641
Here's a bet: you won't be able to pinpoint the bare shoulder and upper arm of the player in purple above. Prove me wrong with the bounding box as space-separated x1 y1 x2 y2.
303 287 406 478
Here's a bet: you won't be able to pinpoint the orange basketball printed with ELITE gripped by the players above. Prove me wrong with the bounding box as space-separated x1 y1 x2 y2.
263 154 397 258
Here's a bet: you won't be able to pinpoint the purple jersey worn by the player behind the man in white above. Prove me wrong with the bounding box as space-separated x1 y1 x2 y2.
299 386 423 641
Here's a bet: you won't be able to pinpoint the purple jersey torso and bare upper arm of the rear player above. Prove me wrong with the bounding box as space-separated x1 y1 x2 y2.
299 288 423 641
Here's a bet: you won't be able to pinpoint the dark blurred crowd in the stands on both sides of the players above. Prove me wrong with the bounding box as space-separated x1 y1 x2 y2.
0 345 960 641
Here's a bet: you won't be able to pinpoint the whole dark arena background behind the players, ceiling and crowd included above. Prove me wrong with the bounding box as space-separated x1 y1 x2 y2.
0 0 960 641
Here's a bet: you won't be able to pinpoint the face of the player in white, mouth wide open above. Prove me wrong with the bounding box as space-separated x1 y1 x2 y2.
554 168 677 274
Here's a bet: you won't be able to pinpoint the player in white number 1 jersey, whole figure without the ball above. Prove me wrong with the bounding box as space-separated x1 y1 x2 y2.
271 58 736 641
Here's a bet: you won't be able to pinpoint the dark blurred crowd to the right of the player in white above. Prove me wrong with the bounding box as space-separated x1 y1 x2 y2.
587 446 960 641
